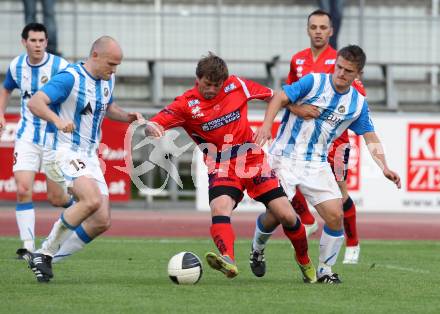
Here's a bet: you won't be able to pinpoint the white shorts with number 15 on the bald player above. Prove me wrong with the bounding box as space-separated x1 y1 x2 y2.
43 148 108 195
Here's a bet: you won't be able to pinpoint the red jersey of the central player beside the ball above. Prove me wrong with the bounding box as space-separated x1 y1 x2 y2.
150 76 273 151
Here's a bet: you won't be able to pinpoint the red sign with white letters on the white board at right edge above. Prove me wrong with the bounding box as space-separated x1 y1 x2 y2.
407 123 440 192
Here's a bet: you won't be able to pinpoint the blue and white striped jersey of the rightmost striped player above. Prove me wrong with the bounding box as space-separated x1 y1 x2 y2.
269 73 374 162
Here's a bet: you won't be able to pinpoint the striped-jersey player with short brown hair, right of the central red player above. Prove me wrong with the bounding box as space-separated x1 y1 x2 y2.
253 45 400 283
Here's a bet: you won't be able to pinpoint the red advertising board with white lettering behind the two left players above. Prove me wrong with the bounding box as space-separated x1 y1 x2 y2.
0 114 131 201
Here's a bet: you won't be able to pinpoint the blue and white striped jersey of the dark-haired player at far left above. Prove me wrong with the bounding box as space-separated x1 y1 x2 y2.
3 53 69 145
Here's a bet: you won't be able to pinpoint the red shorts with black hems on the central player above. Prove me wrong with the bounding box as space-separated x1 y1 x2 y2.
208 150 286 205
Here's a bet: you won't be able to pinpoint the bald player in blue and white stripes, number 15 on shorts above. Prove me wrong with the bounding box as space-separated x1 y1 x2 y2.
22 36 143 281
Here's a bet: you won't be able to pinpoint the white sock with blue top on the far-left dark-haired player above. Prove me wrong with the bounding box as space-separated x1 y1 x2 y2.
15 202 35 252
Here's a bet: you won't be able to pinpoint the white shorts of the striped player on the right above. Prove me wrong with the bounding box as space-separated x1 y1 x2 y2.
269 155 342 206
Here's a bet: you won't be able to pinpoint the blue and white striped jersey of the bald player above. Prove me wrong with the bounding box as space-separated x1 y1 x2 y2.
41 63 115 153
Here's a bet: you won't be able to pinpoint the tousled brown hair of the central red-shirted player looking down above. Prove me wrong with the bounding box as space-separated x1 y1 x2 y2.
196 52 229 83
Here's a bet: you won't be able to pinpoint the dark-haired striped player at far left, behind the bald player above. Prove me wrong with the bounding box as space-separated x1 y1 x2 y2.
0 23 71 254
